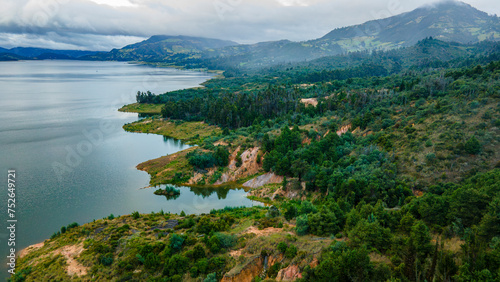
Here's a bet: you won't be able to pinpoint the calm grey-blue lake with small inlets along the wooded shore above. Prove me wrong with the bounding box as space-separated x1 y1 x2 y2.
0 61 257 276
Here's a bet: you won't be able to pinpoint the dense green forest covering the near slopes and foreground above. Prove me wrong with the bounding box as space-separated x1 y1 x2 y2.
12 39 500 281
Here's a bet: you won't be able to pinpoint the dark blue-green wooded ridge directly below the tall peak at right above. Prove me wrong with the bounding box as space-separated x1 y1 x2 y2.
290 38 500 78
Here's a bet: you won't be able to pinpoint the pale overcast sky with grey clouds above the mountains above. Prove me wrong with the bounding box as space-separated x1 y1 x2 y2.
0 0 500 50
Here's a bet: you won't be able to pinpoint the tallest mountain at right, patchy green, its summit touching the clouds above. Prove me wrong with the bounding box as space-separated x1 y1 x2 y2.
316 1 500 51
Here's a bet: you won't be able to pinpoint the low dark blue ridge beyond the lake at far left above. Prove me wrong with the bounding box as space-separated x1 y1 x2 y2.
0 47 97 61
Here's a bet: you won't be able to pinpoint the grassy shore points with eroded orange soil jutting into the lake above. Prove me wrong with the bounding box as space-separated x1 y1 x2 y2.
119 107 282 193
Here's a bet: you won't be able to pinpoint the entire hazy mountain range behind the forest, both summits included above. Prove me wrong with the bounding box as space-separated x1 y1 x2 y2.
94 1 500 69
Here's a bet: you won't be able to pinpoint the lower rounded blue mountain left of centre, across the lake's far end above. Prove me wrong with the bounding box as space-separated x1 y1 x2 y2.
85 35 238 61
